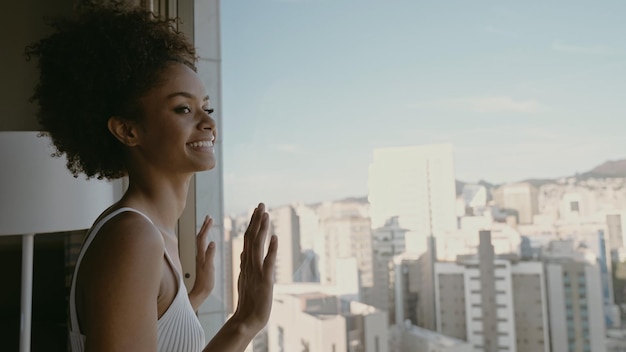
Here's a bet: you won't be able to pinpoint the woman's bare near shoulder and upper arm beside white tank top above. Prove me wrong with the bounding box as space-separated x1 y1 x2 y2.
79 212 164 352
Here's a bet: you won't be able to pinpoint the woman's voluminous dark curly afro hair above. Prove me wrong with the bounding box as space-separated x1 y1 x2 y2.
25 3 197 179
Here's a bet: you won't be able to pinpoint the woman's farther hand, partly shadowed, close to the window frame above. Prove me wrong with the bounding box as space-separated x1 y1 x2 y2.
189 215 215 311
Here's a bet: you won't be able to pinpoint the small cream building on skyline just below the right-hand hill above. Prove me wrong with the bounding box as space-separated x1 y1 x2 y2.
493 182 539 224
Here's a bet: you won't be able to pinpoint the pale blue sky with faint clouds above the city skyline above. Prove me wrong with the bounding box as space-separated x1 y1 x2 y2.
217 0 626 214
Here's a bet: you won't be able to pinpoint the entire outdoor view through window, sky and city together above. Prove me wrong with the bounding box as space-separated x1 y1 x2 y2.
218 0 626 352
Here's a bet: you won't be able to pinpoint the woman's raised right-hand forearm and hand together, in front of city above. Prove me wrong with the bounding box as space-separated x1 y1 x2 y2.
204 203 278 352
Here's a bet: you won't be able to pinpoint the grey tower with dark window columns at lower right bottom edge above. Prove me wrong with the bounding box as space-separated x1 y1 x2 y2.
546 258 606 352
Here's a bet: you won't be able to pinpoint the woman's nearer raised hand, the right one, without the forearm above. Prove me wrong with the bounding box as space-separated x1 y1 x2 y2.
233 203 278 337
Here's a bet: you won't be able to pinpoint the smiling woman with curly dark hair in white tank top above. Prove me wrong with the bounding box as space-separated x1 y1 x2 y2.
27 4 278 351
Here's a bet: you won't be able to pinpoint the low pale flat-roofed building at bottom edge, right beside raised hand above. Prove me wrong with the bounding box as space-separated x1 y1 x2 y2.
267 292 389 352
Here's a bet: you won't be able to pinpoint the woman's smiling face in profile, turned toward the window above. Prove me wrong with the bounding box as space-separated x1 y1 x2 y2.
131 63 217 173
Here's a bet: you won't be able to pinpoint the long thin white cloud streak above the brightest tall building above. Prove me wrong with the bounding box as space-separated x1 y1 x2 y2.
411 96 542 113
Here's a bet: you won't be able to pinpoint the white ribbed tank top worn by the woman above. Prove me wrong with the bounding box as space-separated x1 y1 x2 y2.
69 207 205 352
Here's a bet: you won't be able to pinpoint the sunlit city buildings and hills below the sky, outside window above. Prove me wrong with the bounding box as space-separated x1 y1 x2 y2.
224 144 626 352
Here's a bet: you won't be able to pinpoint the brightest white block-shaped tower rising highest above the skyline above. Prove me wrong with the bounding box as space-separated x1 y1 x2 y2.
368 144 457 254
